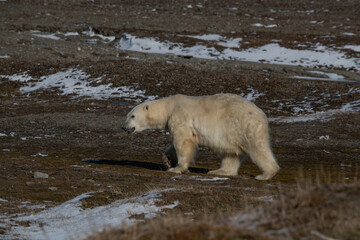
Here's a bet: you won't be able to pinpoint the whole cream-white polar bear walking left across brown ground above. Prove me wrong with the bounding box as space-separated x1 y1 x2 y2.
122 94 280 180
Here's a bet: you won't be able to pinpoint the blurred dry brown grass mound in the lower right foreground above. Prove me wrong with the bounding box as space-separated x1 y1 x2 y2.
89 181 360 240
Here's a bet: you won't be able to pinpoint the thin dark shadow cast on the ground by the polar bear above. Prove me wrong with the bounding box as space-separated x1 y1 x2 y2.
82 159 210 173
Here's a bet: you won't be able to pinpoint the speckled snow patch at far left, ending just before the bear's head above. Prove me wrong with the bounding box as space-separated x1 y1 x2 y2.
0 68 156 101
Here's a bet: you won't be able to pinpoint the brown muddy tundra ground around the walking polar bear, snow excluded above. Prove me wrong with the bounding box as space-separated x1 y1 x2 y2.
0 0 360 238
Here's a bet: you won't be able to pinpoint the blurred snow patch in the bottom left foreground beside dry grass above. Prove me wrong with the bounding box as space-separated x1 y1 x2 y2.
0 189 179 240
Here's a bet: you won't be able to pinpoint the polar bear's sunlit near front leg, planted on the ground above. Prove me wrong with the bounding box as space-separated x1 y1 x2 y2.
168 136 197 173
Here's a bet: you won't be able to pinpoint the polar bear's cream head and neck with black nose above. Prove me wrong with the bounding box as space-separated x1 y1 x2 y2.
122 99 168 134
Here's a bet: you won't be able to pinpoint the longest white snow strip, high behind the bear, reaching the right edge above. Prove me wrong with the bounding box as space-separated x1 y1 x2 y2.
116 34 360 70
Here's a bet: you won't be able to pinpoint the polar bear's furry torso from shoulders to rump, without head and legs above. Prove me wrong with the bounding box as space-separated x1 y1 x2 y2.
169 94 268 154
